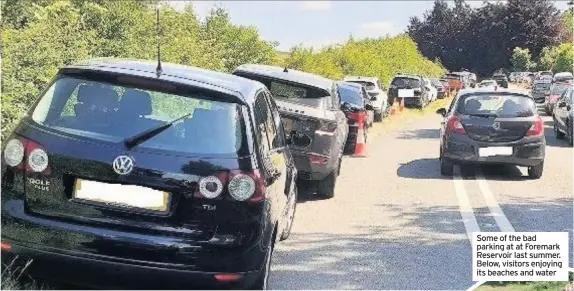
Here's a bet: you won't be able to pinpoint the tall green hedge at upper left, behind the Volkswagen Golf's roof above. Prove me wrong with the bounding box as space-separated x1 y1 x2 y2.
2 0 277 137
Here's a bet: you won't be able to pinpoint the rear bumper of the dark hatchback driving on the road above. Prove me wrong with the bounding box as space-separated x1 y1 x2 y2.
442 135 546 167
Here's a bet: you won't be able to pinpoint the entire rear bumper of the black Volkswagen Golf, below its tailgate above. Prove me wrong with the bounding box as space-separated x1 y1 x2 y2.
2 200 270 289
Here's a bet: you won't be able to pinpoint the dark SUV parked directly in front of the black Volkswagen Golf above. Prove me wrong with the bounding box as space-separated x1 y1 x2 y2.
233 64 349 198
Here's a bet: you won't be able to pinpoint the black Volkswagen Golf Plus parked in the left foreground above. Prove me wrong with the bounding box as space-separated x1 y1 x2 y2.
1 59 297 289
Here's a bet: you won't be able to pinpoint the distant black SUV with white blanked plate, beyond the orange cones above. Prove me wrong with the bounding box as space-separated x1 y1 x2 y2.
388 74 430 108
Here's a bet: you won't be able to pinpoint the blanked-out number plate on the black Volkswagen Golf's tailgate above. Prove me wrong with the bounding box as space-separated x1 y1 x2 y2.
74 179 170 212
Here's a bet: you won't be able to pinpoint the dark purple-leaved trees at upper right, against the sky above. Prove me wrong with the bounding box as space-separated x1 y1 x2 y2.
408 0 562 75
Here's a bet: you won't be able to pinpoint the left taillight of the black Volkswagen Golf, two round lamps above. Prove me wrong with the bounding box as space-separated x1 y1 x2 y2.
3 137 50 174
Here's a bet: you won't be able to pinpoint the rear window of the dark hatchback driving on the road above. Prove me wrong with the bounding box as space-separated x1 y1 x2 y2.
457 94 536 117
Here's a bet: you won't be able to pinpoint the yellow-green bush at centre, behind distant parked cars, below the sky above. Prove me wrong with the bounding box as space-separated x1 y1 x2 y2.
285 35 446 84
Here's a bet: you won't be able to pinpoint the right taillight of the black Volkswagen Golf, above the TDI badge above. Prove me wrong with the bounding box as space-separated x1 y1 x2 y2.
194 170 265 202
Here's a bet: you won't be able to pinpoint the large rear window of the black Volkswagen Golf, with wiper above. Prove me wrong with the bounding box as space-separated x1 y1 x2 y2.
32 76 244 154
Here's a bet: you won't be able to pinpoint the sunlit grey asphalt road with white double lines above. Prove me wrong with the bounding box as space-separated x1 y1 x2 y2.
270 85 573 290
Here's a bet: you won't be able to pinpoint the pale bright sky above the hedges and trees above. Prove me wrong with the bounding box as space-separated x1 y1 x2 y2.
170 0 568 51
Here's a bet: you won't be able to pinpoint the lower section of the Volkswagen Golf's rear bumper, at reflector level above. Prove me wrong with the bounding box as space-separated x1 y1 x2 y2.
2 244 259 290
